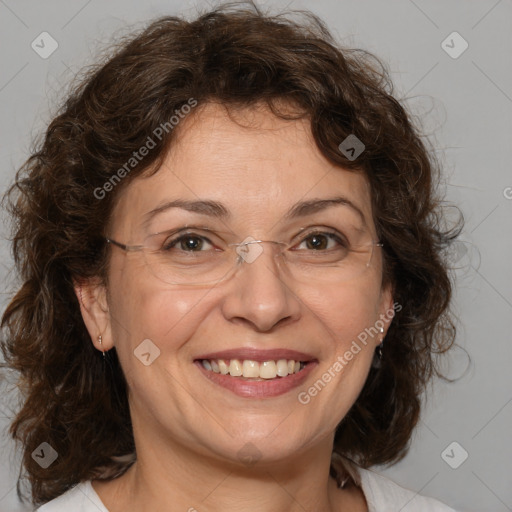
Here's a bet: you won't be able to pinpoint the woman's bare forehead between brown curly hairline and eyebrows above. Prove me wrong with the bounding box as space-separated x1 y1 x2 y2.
113 104 373 235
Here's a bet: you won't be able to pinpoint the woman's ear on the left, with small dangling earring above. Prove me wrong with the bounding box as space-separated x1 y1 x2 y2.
74 278 114 352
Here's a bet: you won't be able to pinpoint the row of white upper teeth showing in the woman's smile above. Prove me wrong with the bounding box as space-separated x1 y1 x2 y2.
202 359 304 379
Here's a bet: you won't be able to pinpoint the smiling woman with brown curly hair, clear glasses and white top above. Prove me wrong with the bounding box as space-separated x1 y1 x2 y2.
2 2 462 512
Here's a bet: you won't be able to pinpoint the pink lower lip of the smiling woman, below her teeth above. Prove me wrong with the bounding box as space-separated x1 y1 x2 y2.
194 361 318 398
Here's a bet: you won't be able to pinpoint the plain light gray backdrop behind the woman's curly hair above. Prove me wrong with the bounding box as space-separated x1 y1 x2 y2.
0 0 512 512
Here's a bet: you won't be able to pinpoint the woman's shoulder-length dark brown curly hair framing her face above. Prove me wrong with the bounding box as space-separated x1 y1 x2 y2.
2 0 460 504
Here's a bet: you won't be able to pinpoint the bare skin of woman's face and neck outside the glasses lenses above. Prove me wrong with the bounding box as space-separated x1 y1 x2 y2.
77 103 393 512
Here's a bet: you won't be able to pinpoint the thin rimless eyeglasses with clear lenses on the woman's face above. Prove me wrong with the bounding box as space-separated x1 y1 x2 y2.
105 228 382 286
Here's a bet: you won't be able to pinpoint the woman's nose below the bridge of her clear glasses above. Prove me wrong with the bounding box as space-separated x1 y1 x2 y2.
222 242 301 332
